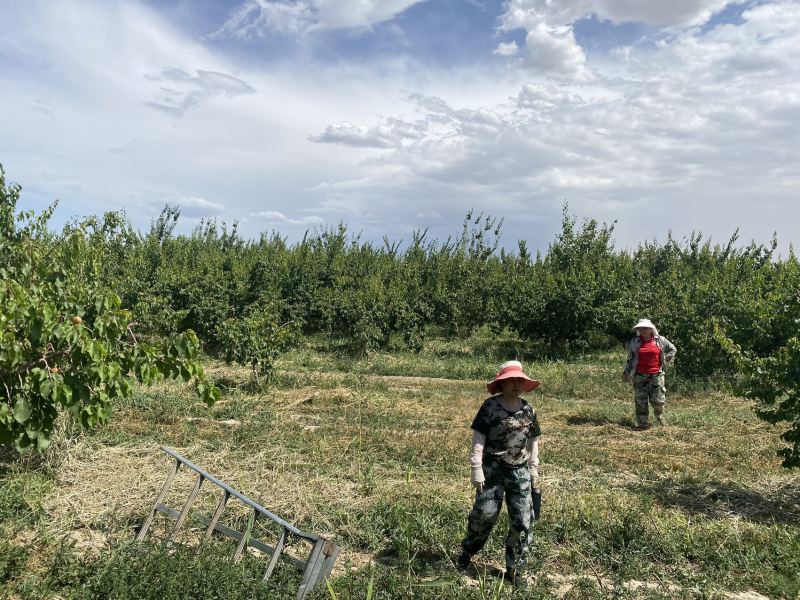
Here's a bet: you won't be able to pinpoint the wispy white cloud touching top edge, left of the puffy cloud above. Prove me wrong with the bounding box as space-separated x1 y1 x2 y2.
212 0 423 38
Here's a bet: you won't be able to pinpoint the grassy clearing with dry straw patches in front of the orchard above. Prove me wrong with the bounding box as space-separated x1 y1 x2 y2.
0 339 800 600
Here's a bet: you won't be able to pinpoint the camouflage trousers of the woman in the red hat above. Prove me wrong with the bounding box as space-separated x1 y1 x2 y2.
461 457 531 571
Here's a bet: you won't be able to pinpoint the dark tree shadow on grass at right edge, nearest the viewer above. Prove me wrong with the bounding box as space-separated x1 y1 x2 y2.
632 479 800 525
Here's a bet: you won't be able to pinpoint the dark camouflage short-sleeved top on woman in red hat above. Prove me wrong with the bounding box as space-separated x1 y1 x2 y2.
472 395 542 466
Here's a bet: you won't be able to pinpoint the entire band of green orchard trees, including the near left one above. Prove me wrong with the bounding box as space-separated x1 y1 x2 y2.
0 164 800 464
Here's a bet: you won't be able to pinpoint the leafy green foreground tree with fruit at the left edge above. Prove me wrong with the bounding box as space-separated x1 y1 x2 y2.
0 168 219 451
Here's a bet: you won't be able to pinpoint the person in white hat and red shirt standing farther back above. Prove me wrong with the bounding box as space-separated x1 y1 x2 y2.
622 319 677 429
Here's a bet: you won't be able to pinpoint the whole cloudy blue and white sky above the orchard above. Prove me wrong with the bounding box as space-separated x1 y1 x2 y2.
0 0 800 251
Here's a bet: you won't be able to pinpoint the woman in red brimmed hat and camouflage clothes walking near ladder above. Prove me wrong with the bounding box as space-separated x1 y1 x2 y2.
458 360 541 586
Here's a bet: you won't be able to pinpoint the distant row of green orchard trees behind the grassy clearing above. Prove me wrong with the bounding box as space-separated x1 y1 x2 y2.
90 207 800 377
